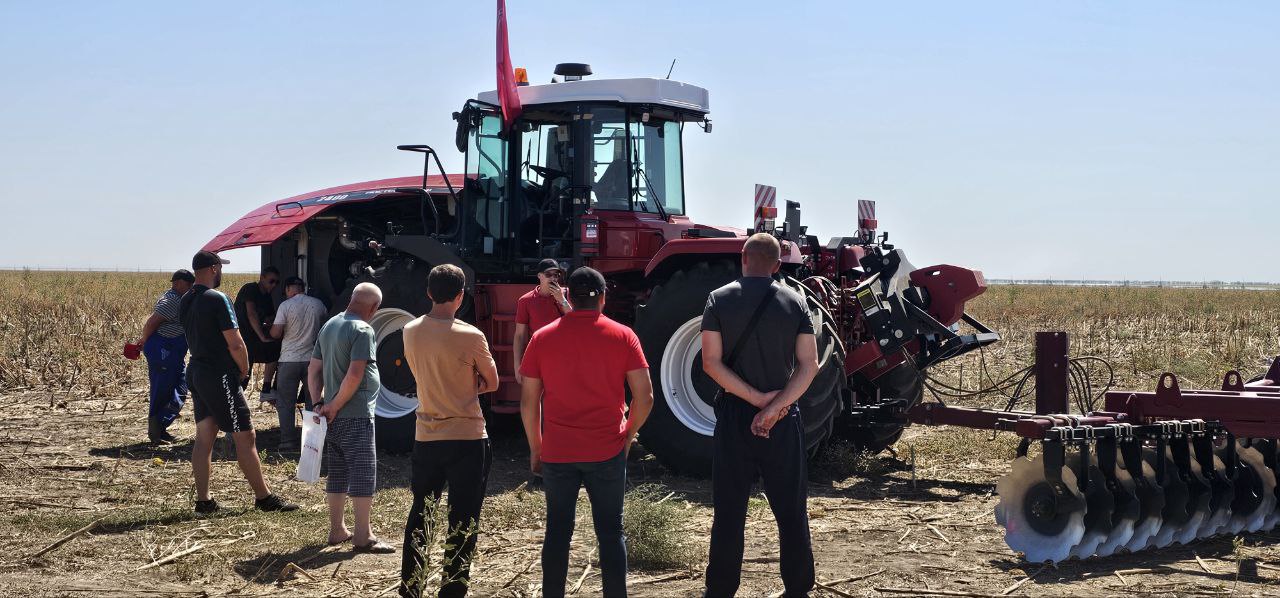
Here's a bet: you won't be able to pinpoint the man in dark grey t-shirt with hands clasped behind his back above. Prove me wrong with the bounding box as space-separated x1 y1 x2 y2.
701 233 818 598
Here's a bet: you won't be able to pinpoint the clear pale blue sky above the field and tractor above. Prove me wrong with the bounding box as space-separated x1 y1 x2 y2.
0 0 1280 280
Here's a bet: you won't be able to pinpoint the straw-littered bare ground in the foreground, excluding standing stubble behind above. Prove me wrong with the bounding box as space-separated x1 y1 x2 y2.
0 389 1280 597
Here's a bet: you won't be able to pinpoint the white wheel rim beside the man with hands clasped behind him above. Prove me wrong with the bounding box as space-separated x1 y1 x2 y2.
659 316 716 437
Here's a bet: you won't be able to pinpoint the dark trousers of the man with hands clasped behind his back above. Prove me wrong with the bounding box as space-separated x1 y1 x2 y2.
707 396 814 598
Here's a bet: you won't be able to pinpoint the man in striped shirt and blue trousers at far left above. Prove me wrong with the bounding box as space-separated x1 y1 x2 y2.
136 270 196 443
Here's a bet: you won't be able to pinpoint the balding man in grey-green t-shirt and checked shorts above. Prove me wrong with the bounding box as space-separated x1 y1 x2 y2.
307 283 396 554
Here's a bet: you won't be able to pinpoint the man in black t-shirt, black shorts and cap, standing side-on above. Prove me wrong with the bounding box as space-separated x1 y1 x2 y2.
178 251 298 513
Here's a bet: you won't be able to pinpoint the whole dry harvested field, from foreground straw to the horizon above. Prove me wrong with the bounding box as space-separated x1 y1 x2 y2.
0 271 1280 597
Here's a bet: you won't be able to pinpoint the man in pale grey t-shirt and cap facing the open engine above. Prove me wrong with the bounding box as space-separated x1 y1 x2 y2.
271 277 329 451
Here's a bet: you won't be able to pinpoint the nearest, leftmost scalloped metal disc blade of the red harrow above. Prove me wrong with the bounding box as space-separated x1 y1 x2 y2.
996 456 1084 562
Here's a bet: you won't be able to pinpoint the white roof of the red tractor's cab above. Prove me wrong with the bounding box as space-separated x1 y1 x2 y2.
477 78 712 115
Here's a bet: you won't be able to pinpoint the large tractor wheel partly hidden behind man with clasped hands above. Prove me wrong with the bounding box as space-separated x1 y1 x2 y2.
635 260 844 476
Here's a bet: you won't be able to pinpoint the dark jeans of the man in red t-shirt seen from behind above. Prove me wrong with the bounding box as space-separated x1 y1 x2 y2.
543 451 627 598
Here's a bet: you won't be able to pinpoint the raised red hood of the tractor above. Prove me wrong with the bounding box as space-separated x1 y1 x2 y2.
204 174 463 252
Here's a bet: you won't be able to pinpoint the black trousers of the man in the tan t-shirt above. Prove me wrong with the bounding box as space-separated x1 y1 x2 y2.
399 438 493 598
